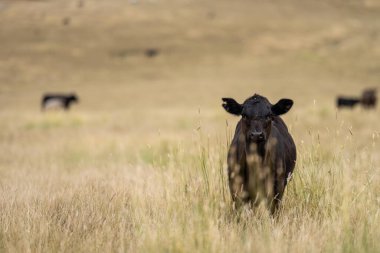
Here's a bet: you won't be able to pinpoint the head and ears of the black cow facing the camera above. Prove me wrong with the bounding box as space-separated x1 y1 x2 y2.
222 94 293 144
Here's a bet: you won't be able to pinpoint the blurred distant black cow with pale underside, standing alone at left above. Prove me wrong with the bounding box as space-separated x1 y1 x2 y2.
41 93 79 110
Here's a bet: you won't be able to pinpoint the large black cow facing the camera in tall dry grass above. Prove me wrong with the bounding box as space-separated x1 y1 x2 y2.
222 94 296 214
